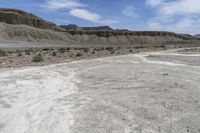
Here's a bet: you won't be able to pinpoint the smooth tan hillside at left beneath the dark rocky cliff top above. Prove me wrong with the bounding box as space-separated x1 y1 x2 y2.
0 23 74 44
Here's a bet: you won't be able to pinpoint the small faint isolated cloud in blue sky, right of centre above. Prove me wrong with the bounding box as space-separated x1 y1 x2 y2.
122 6 138 18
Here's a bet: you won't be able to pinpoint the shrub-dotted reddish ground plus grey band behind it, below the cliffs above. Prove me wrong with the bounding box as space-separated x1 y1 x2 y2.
0 41 173 68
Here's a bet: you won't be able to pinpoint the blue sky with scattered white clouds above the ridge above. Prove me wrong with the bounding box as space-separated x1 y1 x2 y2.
0 0 200 34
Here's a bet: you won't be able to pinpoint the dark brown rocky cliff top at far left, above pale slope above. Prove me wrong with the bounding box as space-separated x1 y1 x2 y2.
0 8 62 31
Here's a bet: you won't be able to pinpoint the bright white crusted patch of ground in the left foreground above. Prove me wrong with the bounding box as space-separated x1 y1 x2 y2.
0 66 77 133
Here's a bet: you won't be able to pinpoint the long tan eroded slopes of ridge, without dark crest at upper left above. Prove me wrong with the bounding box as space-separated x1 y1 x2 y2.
0 23 183 45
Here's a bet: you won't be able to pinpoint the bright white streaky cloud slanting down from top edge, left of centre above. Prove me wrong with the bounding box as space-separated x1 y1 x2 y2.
43 0 117 25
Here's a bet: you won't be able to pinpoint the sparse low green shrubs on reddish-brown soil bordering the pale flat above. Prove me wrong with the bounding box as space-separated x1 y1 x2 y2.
0 44 187 67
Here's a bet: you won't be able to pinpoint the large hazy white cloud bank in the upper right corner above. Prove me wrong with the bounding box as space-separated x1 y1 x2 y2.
146 0 200 34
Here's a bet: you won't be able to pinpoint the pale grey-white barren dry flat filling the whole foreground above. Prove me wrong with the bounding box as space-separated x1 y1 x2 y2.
0 49 200 133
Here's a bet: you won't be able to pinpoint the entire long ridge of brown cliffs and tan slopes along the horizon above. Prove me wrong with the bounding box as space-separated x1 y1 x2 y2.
0 9 197 45
